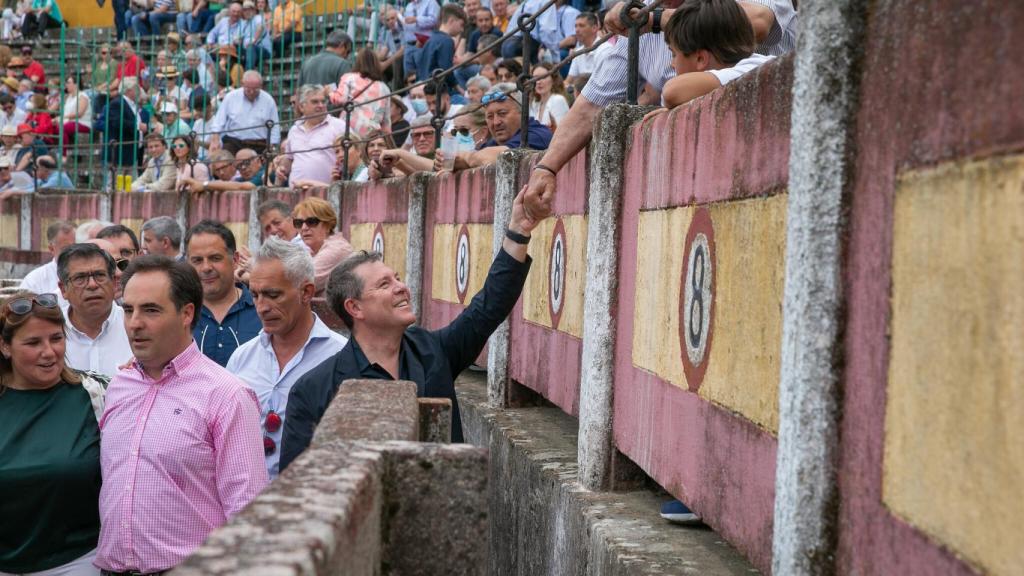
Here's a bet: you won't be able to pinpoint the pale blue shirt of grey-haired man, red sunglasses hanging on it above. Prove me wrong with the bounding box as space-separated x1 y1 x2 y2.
226 313 348 480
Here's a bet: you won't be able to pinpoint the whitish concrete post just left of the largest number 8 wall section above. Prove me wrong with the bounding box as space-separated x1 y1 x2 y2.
578 105 648 490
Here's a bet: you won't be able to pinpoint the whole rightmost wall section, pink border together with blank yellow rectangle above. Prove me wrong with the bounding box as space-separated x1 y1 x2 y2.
837 0 1024 575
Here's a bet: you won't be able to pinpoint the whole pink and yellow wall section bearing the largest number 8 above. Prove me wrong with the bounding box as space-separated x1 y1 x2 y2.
612 57 793 571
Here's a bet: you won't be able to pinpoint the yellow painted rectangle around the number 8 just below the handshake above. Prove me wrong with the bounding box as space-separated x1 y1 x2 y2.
522 214 587 338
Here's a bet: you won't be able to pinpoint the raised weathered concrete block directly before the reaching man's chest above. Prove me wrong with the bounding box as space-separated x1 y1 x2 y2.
310 380 420 440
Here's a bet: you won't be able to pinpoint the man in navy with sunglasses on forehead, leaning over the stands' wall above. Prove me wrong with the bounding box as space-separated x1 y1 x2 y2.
455 84 551 170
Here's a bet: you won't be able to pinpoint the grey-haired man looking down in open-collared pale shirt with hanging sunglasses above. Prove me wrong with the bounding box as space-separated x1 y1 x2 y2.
226 236 348 479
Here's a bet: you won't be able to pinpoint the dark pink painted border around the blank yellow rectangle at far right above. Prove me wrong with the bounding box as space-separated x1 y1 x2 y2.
837 0 1024 576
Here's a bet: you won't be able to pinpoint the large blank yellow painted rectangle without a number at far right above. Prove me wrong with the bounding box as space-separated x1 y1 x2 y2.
883 156 1024 575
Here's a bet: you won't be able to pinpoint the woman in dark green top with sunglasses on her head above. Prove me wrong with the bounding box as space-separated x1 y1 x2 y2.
0 292 103 576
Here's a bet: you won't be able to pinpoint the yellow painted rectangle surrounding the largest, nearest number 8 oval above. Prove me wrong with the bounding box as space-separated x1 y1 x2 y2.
633 194 786 435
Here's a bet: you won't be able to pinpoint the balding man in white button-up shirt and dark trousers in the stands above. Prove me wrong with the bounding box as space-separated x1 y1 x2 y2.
207 70 281 154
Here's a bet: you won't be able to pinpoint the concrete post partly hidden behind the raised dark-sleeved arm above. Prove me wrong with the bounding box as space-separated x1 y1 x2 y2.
487 150 530 408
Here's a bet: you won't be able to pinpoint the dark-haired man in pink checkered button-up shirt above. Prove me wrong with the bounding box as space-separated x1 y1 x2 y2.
95 256 268 575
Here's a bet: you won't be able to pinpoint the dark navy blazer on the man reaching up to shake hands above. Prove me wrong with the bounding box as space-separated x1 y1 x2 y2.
281 250 531 470
